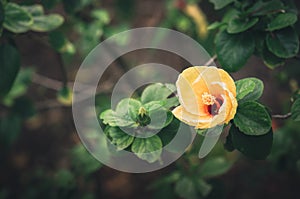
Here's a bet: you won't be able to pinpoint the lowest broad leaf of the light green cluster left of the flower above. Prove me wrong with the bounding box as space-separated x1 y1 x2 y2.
131 135 162 163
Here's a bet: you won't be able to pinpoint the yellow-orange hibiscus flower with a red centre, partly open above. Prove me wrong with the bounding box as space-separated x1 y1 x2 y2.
172 66 238 129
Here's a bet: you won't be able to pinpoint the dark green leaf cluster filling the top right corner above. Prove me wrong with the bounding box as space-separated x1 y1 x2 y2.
209 0 299 72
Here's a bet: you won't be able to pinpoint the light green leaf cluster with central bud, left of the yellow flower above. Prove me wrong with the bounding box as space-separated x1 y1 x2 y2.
100 83 178 163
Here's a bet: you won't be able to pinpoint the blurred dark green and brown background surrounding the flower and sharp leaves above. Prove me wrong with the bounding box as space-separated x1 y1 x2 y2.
0 0 300 199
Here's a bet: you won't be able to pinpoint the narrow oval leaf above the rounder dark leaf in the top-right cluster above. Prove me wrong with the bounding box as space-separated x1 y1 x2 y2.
268 13 297 31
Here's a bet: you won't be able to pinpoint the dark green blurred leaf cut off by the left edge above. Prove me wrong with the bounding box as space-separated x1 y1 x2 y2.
0 44 20 98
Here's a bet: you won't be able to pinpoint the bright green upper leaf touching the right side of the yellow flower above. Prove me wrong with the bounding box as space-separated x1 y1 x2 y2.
235 77 264 103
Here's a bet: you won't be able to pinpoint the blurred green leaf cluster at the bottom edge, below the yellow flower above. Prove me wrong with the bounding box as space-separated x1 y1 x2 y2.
149 139 235 199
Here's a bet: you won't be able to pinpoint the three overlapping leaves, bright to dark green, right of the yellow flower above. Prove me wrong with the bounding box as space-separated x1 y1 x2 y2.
224 78 273 159
